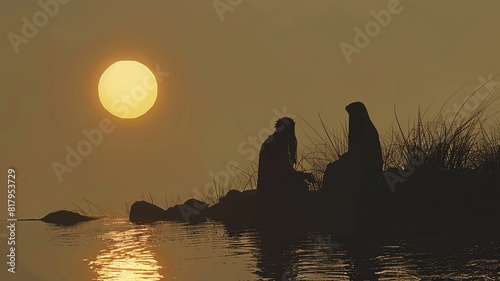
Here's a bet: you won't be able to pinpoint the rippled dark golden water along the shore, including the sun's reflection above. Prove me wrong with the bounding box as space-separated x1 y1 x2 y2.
0 219 500 281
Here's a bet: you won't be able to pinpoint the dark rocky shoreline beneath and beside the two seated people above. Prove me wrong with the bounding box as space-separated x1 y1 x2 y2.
125 171 500 235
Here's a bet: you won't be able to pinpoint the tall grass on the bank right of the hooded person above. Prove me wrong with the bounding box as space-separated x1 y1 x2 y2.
384 83 498 172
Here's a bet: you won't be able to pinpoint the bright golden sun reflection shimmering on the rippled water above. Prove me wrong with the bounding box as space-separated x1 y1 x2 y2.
89 222 163 281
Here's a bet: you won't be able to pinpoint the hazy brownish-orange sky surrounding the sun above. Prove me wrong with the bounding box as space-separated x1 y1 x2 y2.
0 0 500 218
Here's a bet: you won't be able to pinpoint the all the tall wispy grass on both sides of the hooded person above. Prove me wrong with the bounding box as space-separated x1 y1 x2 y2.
298 80 500 186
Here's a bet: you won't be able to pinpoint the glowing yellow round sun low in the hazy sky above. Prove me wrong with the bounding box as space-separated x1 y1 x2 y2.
98 61 158 119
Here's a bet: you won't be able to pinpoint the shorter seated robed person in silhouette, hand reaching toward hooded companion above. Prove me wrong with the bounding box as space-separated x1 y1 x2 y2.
254 117 314 224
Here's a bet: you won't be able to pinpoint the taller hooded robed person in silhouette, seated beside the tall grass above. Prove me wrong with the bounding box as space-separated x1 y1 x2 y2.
320 102 383 234
